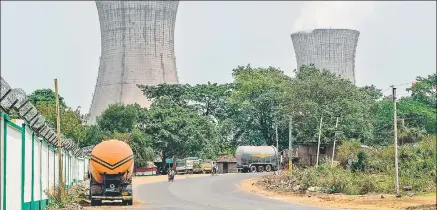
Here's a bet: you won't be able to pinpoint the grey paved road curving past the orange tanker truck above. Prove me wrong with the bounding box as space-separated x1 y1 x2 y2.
135 174 326 210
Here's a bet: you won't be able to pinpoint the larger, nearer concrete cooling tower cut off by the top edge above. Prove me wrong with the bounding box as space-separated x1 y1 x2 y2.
87 1 179 124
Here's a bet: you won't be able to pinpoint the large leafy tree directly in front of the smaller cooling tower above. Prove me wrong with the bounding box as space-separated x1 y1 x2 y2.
288 65 373 142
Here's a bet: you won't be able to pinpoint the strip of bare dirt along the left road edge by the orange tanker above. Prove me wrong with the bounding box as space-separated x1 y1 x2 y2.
82 174 211 210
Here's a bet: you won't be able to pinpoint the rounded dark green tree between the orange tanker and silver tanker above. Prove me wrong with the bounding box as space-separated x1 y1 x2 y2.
143 99 216 162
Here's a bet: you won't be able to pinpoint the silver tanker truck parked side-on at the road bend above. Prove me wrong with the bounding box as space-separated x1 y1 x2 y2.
235 146 279 172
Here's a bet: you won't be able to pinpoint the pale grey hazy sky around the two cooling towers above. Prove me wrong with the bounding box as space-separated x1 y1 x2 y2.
1 1 436 112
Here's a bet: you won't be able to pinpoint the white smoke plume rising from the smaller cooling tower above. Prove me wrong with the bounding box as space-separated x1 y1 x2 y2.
293 1 375 32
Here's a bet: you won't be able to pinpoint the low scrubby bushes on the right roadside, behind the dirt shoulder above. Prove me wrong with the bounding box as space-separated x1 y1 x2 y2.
265 136 436 195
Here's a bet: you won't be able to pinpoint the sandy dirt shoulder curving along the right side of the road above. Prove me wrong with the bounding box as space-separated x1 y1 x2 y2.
240 178 436 210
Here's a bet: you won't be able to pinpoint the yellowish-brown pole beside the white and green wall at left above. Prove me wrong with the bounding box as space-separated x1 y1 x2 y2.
55 79 64 199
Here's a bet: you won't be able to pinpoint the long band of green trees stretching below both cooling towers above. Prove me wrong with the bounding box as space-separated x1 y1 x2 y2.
22 65 436 166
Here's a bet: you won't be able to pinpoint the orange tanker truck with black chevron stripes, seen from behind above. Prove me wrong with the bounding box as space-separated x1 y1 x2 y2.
88 140 134 206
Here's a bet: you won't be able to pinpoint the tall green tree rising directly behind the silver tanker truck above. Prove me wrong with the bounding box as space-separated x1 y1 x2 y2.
228 65 291 148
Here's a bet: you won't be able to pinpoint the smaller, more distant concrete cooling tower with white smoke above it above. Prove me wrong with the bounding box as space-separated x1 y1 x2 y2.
291 29 360 84
